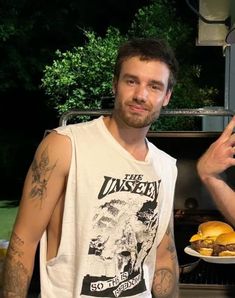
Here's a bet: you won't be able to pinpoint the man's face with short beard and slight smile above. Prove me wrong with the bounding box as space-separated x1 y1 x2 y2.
113 57 171 128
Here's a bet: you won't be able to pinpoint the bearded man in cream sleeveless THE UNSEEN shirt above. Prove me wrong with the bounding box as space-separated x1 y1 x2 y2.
3 39 178 298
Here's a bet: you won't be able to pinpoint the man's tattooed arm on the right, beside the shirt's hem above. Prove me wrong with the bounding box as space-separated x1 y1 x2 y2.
152 215 179 298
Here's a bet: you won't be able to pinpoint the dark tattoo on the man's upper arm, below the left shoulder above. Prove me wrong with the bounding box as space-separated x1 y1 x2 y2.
30 147 56 200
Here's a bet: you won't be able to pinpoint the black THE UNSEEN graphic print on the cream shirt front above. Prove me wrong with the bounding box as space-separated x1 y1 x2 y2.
81 174 161 297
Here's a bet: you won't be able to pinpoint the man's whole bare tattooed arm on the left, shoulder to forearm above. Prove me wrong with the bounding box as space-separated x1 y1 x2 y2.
1 132 71 298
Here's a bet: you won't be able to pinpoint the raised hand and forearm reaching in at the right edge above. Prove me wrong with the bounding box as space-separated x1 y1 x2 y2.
197 116 235 225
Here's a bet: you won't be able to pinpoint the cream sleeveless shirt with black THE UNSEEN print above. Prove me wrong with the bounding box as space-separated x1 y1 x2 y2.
40 116 177 298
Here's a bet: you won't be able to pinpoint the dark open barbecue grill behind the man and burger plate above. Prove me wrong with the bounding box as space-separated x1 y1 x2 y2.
151 132 235 298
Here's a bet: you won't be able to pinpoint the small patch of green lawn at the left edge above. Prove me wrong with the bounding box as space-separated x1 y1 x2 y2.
0 201 18 240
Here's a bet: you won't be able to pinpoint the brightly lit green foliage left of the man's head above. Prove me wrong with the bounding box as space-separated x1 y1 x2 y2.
42 27 124 115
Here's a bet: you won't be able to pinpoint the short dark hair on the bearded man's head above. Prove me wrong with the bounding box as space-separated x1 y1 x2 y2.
114 38 178 90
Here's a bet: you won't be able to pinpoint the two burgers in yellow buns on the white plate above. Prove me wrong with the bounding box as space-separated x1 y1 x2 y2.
189 220 235 256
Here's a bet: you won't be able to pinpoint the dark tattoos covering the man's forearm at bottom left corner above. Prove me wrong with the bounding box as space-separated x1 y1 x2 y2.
3 233 30 298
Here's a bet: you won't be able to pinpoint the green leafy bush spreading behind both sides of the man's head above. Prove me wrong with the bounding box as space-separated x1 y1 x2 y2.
42 0 217 130
